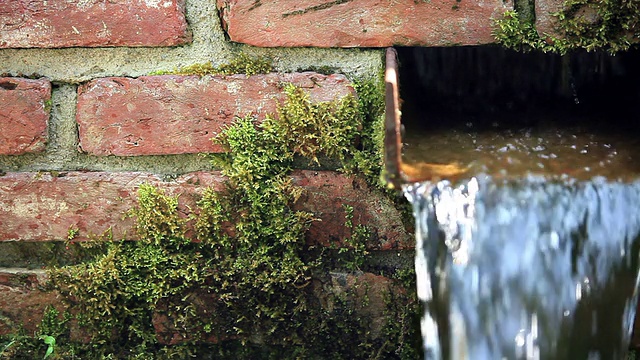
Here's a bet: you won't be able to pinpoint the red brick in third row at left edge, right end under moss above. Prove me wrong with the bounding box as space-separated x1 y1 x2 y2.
0 172 222 241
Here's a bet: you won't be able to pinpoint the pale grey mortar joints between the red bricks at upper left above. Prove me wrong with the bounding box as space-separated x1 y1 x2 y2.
0 0 383 174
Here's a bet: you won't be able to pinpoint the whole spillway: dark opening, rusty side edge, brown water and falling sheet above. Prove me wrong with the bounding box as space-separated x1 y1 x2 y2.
386 48 640 359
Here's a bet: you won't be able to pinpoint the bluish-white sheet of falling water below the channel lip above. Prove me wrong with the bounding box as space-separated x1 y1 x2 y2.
404 177 640 360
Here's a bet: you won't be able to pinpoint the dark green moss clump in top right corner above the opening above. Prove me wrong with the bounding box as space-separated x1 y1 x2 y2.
494 0 640 54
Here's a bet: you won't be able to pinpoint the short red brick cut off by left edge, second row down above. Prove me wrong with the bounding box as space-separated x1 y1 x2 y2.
0 77 51 155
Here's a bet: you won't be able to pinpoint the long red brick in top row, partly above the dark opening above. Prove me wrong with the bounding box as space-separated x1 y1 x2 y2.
217 0 513 47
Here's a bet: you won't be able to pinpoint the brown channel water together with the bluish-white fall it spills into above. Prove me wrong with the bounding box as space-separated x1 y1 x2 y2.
404 117 640 360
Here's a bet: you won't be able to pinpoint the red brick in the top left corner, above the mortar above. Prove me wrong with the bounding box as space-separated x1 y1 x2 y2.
0 0 191 48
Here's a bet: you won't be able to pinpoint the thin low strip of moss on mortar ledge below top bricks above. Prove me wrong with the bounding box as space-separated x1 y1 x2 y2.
151 53 273 76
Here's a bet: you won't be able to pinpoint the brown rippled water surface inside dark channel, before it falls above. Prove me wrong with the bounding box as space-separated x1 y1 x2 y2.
403 114 640 181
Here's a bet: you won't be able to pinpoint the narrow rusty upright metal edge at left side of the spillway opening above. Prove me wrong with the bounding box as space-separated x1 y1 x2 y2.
384 47 404 189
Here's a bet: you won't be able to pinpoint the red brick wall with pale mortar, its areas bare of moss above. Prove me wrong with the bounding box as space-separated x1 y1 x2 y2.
0 0 636 352
